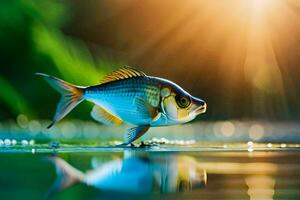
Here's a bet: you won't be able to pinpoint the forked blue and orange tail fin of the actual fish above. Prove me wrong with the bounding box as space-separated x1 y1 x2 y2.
36 73 84 128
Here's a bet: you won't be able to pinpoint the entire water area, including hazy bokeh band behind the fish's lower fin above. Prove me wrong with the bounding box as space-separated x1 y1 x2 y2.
0 120 300 200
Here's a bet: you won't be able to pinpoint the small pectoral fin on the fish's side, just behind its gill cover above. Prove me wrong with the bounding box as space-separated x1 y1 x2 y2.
134 97 159 121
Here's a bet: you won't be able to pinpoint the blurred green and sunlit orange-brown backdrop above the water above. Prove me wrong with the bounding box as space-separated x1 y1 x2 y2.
0 0 300 121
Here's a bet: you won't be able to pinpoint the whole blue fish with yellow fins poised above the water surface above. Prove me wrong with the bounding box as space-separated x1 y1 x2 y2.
36 66 207 145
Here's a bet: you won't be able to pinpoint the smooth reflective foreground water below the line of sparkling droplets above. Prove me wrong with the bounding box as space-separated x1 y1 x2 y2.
0 142 300 200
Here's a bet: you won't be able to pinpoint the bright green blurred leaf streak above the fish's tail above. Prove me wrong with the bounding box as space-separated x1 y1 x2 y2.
32 25 107 85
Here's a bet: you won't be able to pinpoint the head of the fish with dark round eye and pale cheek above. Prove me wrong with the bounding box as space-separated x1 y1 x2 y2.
161 83 207 123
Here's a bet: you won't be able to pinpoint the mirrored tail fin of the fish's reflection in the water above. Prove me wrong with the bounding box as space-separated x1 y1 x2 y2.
44 156 84 199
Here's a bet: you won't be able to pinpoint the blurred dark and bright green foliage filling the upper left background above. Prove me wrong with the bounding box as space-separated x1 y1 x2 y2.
0 0 118 120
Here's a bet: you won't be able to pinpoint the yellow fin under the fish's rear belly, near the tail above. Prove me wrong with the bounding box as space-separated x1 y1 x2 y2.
91 105 123 126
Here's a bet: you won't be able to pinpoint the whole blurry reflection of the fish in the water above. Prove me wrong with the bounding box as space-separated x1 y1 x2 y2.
45 156 206 198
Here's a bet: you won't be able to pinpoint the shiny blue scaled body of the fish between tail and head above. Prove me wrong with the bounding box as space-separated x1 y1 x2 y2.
85 77 159 124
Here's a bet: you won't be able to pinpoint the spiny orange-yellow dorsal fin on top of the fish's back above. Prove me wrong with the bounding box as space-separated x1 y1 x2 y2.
100 66 146 83
